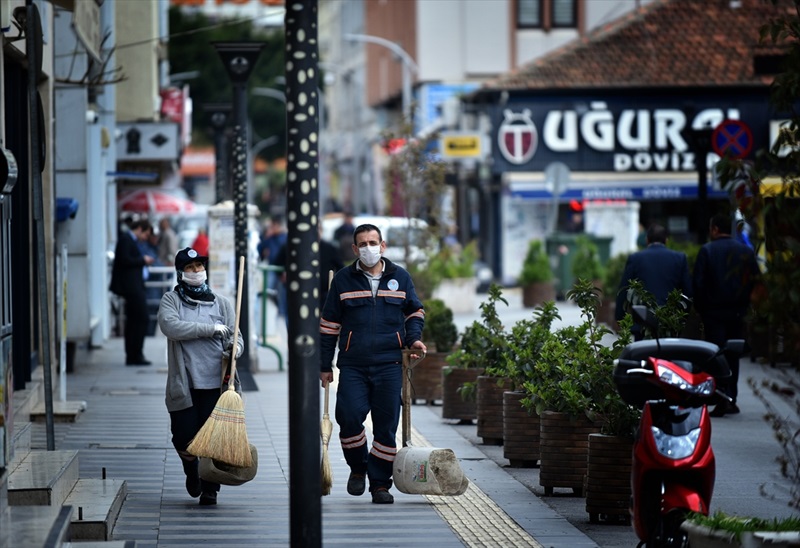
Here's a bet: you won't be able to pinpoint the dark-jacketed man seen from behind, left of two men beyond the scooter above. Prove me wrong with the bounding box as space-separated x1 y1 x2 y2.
615 224 692 340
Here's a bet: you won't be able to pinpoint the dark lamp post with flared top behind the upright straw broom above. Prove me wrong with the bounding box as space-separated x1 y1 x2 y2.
213 42 264 371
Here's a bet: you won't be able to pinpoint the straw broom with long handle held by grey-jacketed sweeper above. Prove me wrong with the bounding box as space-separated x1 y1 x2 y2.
187 257 253 467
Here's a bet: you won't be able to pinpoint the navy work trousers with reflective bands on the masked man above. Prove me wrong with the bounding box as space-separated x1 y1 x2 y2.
336 363 402 492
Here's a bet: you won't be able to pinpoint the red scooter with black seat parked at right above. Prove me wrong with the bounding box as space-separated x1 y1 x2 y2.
614 306 744 548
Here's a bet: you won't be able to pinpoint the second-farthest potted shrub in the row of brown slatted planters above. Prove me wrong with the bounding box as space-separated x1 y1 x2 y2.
442 284 508 422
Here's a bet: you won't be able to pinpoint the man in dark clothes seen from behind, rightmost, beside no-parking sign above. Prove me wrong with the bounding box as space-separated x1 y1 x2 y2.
693 214 760 417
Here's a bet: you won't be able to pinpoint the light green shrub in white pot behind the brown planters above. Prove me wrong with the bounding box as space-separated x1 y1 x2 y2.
427 241 479 313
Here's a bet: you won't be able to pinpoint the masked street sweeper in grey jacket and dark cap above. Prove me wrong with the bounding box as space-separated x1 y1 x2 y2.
158 247 244 506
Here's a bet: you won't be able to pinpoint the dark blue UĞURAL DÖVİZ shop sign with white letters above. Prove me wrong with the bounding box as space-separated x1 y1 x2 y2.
493 94 770 173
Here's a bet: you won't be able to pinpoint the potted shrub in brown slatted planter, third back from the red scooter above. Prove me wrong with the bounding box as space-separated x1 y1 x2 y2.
502 300 561 468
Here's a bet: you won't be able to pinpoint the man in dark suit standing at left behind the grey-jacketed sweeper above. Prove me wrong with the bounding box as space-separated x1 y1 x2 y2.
110 220 153 365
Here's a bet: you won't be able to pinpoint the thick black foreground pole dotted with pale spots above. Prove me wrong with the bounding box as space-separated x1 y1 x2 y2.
285 0 327 548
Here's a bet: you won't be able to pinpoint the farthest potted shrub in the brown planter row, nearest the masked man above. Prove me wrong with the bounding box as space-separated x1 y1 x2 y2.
411 299 458 403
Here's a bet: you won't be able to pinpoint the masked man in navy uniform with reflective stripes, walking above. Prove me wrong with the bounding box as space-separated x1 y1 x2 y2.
320 224 427 504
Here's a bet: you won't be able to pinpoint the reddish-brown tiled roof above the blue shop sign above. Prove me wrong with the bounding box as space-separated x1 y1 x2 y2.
483 0 793 90
